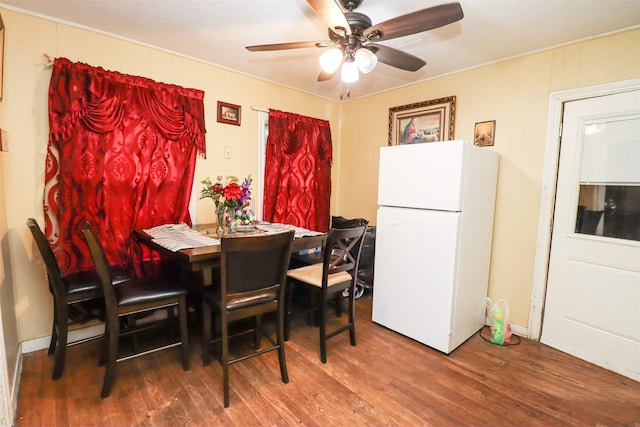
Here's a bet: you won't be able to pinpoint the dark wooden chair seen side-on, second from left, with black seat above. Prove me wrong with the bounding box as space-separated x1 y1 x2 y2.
82 222 189 398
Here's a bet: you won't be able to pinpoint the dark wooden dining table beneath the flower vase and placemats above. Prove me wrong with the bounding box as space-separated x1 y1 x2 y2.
134 223 327 285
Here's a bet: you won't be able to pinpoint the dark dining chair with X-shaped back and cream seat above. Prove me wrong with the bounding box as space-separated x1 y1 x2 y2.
285 224 367 363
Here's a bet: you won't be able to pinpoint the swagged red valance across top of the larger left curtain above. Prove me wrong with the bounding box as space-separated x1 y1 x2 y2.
49 58 206 156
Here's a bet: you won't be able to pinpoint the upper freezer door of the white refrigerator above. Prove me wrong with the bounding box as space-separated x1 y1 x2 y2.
378 141 468 211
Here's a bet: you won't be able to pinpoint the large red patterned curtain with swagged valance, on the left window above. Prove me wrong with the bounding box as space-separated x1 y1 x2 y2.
44 58 206 273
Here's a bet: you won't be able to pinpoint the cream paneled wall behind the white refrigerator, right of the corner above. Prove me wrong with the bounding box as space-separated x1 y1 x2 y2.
336 30 640 328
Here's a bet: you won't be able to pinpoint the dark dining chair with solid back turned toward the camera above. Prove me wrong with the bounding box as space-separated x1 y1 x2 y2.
202 231 294 408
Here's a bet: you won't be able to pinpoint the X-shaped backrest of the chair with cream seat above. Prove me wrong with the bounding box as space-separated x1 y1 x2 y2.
322 223 368 287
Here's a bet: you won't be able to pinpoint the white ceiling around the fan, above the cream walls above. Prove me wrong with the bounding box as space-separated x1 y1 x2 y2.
0 0 640 100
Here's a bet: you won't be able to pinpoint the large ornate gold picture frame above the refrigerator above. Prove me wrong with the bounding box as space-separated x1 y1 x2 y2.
389 96 456 145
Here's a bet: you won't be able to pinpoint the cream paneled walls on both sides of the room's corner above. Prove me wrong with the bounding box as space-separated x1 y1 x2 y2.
0 4 640 340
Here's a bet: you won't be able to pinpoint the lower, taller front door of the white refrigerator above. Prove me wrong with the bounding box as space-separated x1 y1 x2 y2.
372 207 461 353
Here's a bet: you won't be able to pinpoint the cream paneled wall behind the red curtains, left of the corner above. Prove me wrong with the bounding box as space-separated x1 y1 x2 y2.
0 8 339 341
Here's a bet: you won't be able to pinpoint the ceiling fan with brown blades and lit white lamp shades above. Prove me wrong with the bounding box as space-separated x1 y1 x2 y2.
246 0 464 83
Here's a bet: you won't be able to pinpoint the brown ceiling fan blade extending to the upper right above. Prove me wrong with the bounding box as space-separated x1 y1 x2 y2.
365 2 464 41
